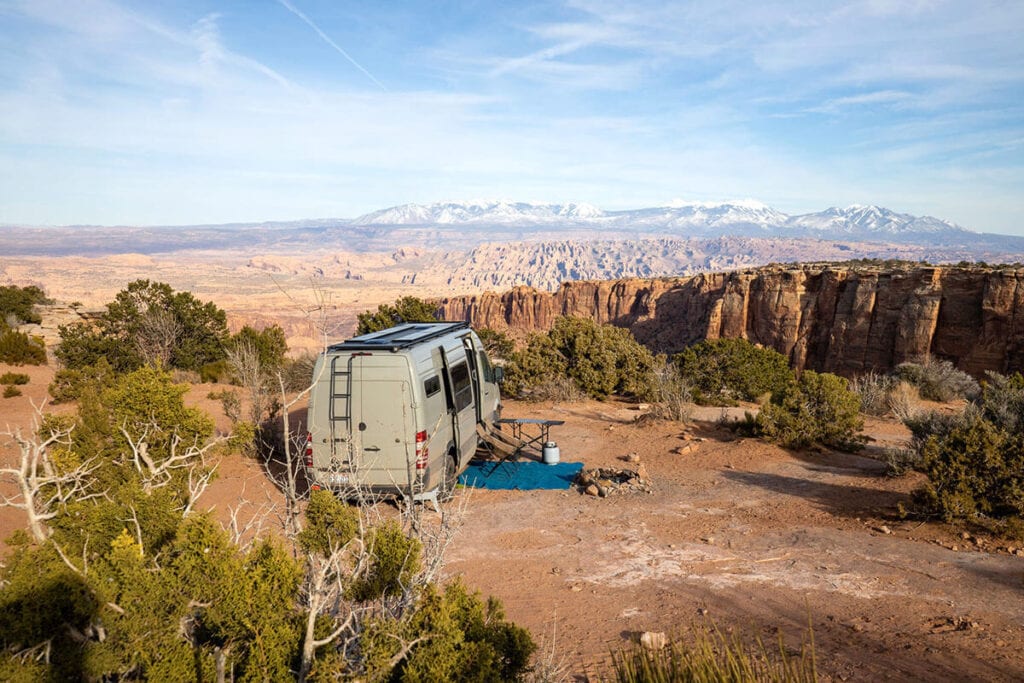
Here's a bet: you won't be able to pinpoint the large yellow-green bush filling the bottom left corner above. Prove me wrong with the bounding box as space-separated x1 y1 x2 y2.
0 511 301 681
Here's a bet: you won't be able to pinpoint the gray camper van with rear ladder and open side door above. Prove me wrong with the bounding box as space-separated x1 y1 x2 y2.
304 323 501 499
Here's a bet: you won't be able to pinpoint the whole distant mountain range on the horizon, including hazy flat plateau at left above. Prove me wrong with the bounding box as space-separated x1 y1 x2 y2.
0 200 1024 260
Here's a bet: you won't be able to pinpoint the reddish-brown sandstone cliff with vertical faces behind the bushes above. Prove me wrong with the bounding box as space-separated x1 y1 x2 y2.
442 264 1024 376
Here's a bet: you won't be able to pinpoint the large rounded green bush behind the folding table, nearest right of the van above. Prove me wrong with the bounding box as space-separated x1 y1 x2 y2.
505 317 658 398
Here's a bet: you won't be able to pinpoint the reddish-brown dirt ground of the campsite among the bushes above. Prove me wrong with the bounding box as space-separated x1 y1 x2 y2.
0 366 1024 681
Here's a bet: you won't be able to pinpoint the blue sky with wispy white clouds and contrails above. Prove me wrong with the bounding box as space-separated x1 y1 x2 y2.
0 0 1024 234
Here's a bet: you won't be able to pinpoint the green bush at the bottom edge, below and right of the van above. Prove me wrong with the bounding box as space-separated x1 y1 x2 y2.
360 581 537 683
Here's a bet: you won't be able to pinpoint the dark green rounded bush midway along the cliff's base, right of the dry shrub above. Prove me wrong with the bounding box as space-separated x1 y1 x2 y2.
675 339 793 405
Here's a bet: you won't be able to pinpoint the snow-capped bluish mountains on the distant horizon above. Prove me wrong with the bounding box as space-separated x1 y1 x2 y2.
350 200 973 242
